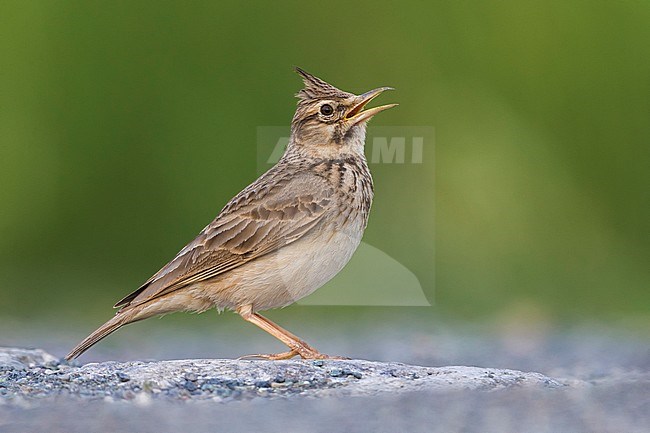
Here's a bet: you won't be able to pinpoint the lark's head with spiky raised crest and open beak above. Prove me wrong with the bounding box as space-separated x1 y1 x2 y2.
290 68 397 158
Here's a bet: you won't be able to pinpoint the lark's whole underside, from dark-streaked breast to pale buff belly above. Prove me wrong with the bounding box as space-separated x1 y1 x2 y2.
192 158 373 311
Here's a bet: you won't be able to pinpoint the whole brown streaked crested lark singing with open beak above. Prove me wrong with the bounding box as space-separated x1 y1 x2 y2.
66 67 398 360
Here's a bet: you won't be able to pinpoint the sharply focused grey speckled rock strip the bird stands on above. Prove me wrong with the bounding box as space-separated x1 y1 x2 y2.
0 348 567 404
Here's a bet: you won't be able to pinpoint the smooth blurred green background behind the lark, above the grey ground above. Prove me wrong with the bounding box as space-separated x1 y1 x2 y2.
0 0 650 329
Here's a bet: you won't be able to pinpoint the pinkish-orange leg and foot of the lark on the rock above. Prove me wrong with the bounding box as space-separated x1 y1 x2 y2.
237 305 331 360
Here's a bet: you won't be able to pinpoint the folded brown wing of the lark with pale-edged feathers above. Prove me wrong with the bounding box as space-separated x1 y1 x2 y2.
115 173 334 308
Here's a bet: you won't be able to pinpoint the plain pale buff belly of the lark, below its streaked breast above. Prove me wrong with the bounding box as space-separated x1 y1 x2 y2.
188 221 363 311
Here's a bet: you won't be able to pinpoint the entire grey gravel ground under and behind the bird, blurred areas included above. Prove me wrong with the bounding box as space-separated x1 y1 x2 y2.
0 311 650 433
